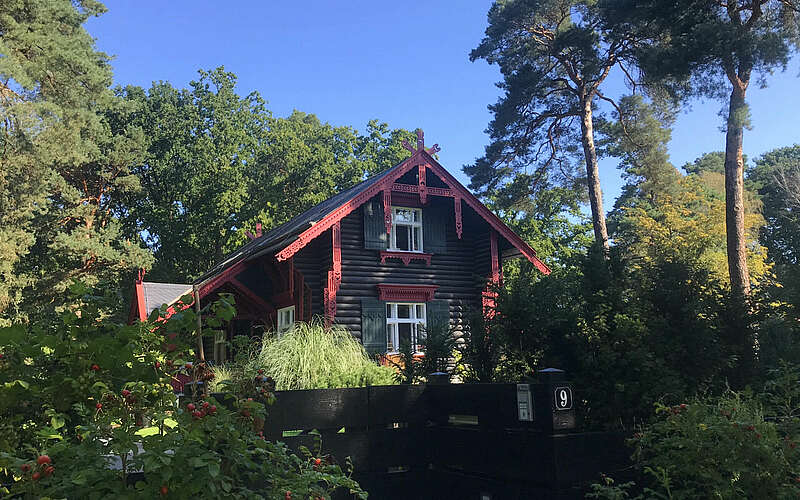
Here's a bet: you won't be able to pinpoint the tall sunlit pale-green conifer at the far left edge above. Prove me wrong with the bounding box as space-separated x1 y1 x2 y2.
0 0 152 324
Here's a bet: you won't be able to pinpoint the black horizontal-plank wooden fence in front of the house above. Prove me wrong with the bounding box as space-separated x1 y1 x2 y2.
264 376 629 500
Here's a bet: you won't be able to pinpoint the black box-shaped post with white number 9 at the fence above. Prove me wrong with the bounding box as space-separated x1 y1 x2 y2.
533 368 575 432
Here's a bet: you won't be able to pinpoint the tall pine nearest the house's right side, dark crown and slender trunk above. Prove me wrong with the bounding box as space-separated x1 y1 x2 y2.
464 0 627 249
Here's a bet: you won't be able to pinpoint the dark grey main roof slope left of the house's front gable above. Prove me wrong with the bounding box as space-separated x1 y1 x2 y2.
194 162 403 285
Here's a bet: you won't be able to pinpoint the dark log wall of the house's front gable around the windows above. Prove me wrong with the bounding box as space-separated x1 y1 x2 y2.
334 197 489 338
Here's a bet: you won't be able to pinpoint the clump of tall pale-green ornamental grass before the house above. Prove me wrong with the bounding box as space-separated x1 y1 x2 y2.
255 320 394 390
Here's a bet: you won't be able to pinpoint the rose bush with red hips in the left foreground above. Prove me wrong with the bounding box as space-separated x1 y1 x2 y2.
0 286 366 499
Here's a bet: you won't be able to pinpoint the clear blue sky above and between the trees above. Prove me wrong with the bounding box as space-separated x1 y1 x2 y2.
87 0 800 210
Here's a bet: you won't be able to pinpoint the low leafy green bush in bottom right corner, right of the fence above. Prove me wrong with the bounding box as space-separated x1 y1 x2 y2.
593 393 800 499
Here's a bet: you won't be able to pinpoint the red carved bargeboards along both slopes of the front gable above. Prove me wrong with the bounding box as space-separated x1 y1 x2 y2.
275 138 550 274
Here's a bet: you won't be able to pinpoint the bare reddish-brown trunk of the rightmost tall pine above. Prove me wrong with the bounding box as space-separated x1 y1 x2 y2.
725 83 750 298
